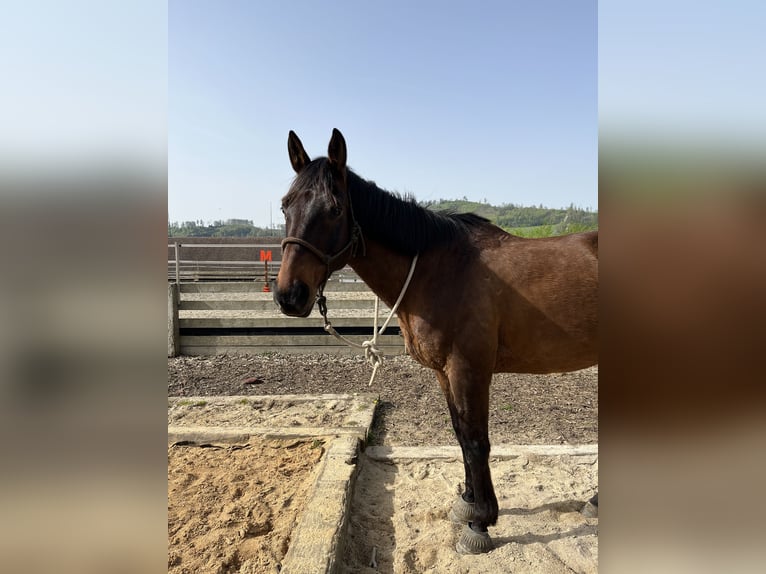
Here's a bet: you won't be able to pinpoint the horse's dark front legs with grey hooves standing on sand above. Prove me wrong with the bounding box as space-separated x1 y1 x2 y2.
440 370 498 554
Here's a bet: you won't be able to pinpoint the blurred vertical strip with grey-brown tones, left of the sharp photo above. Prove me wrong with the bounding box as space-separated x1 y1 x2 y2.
0 0 167 573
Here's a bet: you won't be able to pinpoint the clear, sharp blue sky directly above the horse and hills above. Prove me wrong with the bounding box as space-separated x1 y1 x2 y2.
168 0 598 225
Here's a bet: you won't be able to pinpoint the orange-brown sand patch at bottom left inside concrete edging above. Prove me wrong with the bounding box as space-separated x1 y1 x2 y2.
168 440 322 574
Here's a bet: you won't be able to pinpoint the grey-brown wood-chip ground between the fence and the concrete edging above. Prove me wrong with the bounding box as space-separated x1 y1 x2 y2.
168 353 598 446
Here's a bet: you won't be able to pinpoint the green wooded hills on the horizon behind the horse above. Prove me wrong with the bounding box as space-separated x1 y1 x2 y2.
168 199 598 237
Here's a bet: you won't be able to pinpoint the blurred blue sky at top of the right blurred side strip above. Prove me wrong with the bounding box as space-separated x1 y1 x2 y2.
598 0 766 144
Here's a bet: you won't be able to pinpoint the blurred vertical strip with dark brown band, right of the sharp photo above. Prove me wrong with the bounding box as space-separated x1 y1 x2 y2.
599 1 766 572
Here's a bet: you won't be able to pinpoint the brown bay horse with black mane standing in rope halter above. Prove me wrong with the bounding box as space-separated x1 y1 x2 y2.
273 129 598 554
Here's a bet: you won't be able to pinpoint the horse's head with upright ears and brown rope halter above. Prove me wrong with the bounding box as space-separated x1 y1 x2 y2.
274 129 361 317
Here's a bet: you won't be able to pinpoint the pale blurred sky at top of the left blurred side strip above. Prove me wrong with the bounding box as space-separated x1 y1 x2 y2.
0 0 168 166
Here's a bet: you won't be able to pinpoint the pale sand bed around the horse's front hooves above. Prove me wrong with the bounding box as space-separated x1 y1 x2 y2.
341 453 598 574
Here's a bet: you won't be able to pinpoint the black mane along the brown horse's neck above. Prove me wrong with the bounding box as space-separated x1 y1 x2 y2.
348 169 489 255
